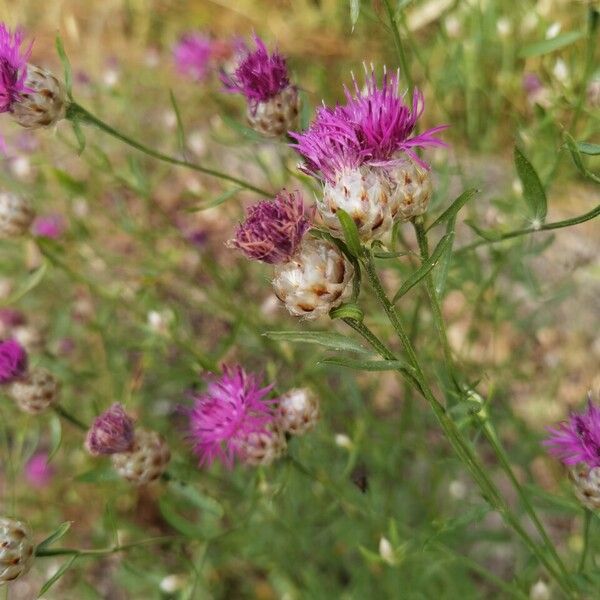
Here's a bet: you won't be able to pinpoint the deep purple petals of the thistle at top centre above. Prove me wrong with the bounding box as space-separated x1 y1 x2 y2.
221 35 290 106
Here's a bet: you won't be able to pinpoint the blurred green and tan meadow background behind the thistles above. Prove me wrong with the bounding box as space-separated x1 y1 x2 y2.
0 0 600 600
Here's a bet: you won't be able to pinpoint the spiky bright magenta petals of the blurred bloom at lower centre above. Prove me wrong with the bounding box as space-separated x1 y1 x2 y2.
185 366 275 468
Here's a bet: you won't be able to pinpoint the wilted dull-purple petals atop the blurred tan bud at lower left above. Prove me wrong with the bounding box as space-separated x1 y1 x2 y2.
85 402 134 455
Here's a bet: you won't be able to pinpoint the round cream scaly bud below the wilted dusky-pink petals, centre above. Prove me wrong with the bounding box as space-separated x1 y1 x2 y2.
273 238 354 319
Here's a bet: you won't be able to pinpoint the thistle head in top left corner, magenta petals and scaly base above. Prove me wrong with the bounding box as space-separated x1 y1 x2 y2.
0 23 67 129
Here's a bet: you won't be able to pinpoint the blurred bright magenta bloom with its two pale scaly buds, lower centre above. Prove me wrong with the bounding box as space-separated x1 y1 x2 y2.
184 366 318 468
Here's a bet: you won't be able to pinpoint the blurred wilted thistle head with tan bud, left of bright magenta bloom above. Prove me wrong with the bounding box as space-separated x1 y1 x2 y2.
85 402 171 485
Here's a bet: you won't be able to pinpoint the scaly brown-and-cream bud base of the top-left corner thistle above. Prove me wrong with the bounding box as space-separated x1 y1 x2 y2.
10 64 67 129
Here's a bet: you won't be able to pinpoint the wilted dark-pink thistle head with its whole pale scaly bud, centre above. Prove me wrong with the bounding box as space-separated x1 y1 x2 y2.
229 190 354 319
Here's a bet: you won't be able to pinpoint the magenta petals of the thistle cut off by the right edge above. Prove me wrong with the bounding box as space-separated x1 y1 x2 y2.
543 397 600 469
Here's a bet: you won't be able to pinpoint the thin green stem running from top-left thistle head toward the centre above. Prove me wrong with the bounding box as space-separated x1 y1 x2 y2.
66 102 272 197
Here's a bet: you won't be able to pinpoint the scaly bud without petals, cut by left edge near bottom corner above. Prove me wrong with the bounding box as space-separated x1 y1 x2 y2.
0 517 34 585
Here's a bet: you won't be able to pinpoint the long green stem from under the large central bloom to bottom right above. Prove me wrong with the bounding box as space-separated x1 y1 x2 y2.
358 253 573 597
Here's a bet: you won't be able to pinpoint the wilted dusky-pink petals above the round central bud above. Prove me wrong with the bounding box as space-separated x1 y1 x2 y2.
229 190 312 265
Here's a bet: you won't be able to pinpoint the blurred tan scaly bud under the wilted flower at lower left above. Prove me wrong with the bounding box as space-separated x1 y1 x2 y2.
112 429 171 485
